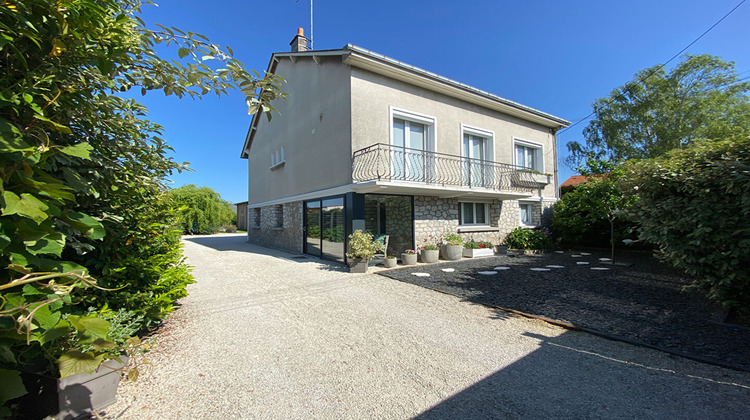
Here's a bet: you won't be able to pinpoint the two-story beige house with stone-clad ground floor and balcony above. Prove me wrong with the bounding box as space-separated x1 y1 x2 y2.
242 30 569 262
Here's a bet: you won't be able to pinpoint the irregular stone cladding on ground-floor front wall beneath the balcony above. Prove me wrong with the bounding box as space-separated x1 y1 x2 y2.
414 196 554 247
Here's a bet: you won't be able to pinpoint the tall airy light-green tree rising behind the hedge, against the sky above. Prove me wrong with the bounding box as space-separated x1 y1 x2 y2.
567 55 750 174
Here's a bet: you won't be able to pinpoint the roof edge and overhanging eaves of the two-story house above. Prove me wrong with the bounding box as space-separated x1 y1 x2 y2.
240 44 570 158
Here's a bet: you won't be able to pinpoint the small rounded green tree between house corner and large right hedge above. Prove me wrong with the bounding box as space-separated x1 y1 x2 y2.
552 171 635 260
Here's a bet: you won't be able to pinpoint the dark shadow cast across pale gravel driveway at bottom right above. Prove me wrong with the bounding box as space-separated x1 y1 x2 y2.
415 332 750 419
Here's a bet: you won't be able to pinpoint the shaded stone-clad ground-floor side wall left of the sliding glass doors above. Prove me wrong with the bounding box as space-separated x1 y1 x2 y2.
247 201 303 253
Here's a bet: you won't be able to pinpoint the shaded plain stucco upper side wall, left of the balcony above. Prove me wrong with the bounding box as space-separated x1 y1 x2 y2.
248 56 352 207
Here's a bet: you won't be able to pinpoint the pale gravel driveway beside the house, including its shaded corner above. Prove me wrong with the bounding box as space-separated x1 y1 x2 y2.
106 234 750 419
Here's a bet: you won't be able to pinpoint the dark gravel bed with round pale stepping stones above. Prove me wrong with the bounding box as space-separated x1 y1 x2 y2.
381 252 750 371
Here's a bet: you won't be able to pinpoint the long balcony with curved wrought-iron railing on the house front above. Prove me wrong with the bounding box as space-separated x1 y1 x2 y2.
352 143 549 199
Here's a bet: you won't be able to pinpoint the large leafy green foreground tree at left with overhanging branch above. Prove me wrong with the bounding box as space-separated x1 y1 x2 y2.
0 0 283 415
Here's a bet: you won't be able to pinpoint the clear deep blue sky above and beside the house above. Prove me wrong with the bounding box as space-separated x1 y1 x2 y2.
131 0 750 202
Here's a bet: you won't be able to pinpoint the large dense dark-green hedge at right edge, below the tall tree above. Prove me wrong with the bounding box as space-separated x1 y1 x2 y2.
620 135 750 309
